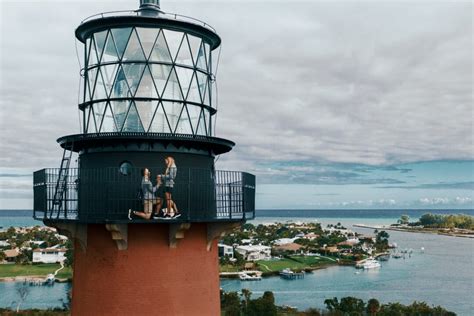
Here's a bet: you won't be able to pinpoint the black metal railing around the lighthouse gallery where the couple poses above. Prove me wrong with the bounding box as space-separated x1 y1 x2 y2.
33 168 255 223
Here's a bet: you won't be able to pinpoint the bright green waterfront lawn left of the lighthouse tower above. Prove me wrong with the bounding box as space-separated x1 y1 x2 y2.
0 263 72 279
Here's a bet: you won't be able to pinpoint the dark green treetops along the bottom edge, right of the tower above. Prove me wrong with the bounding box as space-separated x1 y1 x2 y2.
221 289 456 316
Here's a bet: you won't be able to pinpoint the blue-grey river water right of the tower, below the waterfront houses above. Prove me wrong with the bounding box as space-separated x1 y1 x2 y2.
221 229 474 315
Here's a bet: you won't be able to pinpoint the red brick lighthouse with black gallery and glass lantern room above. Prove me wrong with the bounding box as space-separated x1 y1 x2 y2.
33 0 255 315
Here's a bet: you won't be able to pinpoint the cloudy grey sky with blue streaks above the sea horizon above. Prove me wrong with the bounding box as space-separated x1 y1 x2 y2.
0 0 474 209
